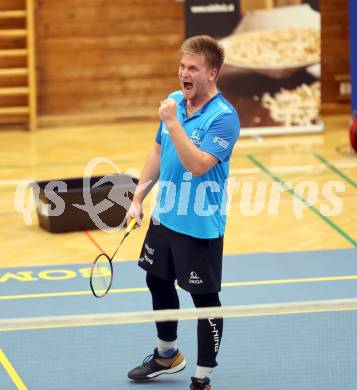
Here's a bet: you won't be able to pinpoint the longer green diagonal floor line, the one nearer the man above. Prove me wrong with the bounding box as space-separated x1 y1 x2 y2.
247 154 357 248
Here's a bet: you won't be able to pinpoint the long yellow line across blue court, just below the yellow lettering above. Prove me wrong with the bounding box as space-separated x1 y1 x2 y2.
0 275 357 301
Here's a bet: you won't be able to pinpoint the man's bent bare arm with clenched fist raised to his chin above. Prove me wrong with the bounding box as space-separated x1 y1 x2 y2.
159 99 218 176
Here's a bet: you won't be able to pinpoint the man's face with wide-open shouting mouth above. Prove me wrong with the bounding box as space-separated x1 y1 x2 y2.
178 53 217 100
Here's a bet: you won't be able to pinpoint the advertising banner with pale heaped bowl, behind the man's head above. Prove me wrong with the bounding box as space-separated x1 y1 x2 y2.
185 0 323 135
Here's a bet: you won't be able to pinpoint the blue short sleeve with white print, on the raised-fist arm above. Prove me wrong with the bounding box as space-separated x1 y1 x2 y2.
200 113 240 162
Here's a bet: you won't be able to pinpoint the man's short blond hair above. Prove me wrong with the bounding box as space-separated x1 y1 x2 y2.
181 35 224 75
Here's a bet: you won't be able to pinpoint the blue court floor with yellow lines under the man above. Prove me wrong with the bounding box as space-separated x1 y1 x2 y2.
0 249 357 390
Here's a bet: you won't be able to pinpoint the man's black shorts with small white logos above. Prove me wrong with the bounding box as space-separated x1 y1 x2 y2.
139 221 223 294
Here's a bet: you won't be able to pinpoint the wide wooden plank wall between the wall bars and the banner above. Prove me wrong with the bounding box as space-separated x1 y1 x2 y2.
35 0 184 123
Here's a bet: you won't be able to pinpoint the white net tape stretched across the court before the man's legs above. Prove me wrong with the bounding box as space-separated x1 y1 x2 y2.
0 298 357 331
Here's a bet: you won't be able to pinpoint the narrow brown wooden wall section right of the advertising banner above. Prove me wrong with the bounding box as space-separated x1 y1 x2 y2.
320 0 350 113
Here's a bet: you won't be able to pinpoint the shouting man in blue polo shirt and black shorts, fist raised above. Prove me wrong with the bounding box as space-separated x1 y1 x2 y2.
127 35 240 390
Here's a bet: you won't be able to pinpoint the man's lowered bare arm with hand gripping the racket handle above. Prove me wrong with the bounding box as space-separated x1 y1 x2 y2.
126 142 161 225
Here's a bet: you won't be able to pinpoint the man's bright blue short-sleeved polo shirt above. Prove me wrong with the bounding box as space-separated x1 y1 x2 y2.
153 91 240 238
